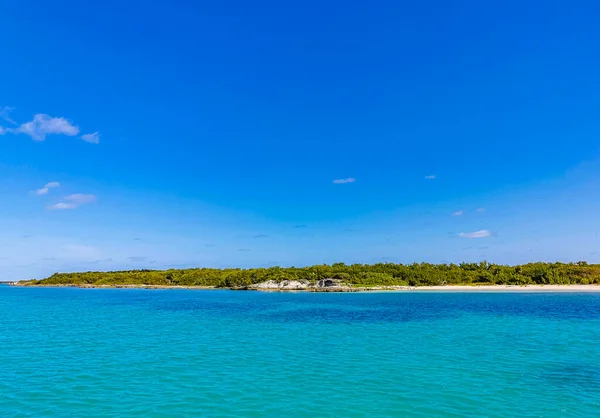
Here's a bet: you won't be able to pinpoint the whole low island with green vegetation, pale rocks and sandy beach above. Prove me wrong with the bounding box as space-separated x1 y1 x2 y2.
12 261 600 292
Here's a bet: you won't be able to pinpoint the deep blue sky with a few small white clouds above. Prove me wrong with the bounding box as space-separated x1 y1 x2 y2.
0 0 600 280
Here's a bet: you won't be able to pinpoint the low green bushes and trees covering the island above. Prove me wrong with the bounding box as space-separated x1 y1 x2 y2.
21 262 600 288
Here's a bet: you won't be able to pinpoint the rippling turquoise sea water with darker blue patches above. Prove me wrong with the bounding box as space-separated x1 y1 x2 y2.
0 286 600 417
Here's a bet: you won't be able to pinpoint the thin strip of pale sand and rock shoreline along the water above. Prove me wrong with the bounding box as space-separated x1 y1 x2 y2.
3 282 600 293
